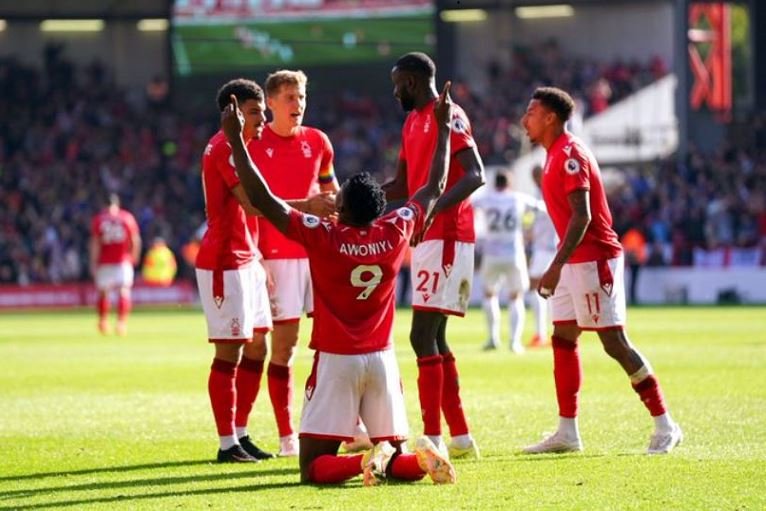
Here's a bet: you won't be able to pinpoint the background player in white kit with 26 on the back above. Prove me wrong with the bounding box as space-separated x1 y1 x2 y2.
474 172 544 353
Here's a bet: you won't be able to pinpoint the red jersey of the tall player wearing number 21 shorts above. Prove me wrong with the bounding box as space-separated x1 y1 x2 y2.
399 100 476 243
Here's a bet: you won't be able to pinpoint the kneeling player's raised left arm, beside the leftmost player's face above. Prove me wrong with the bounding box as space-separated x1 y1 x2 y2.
221 94 290 232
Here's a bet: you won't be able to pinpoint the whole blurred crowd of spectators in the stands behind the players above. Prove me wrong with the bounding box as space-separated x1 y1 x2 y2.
0 41 766 285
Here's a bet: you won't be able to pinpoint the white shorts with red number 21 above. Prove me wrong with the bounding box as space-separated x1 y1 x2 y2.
410 240 473 316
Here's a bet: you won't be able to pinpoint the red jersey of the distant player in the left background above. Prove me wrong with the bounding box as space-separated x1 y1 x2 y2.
90 209 138 264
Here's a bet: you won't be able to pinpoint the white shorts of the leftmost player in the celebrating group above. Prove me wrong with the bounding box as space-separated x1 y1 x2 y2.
197 262 272 343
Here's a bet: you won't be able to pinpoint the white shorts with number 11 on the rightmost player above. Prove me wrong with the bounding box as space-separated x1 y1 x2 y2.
548 255 627 330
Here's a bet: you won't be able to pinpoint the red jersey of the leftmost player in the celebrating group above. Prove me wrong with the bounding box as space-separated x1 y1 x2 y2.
196 131 257 270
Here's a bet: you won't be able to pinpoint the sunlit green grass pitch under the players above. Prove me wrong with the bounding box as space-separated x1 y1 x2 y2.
0 307 766 510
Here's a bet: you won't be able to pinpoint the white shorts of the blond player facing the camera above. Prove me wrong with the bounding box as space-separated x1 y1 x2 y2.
263 258 314 323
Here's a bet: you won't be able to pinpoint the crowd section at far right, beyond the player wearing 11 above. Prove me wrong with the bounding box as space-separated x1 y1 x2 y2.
610 140 766 267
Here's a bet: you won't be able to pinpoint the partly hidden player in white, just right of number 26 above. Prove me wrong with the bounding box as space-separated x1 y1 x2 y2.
529 165 559 348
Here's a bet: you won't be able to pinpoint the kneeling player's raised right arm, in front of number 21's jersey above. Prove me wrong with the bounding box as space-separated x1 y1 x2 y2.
412 81 452 218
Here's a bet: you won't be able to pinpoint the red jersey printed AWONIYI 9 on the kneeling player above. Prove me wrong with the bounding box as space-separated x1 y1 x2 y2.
287 202 423 355
